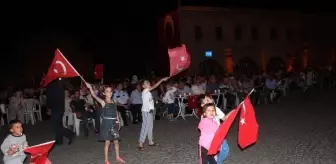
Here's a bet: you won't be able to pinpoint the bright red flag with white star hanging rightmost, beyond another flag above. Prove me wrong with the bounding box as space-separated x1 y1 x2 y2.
238 96 259 149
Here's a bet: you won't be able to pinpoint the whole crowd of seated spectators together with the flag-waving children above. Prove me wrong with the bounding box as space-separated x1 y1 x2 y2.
0 64 336 164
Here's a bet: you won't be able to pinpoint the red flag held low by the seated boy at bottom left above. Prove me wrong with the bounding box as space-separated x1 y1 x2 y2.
24 141 55 164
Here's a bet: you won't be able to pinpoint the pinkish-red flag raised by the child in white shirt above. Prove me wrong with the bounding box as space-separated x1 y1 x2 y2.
168 44 190 76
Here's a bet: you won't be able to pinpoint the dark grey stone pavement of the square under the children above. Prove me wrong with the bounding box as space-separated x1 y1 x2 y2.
0 91 336 164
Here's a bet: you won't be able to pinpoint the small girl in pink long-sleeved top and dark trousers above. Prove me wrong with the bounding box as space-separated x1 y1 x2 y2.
198 104 219 164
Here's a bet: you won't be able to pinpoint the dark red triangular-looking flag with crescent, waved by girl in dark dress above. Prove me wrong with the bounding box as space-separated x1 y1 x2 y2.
44 49 80 86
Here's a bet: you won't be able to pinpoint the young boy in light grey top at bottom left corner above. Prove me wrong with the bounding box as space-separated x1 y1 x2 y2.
1 120 28 164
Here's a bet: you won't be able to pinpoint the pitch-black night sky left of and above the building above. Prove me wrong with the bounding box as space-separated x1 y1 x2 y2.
0 0 330 83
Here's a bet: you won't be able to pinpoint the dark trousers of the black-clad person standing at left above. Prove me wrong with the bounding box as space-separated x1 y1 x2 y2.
51 114 73 144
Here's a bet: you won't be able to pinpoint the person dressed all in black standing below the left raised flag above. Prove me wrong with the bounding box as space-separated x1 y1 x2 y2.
46 79 74 145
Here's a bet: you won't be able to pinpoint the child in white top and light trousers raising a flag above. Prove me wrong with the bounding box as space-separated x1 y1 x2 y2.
138 77 169 151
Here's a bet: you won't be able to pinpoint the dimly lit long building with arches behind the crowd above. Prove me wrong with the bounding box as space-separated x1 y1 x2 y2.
159 6 335 72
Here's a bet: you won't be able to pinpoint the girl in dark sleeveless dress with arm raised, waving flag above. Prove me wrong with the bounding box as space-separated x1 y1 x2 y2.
86 83 125 164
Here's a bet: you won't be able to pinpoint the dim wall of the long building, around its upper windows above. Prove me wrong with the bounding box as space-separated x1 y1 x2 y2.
179 6 331 70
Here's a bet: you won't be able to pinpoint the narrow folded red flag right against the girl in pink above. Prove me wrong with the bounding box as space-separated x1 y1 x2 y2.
208 108 240 155
